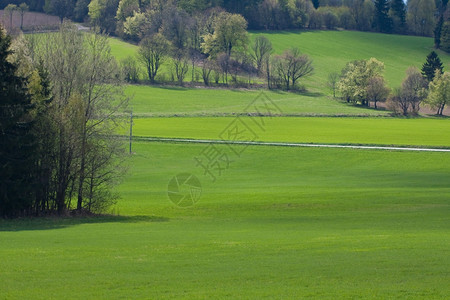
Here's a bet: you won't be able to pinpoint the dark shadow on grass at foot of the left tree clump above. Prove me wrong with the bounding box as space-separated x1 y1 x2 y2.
0 215 170 232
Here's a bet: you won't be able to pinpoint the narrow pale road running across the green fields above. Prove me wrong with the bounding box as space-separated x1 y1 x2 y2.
134 136 450 152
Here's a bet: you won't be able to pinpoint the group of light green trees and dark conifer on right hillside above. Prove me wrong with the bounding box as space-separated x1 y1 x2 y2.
328 51 450 116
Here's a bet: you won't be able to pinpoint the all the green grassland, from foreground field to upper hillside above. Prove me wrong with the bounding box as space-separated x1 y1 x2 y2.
0 31 450 299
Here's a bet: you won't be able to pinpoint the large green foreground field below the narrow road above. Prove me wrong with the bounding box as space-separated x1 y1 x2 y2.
0 143 450 299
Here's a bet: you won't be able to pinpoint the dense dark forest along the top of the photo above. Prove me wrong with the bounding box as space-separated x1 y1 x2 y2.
0 0 448 36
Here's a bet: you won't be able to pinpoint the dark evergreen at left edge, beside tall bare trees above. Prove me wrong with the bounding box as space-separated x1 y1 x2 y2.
0 27 36 217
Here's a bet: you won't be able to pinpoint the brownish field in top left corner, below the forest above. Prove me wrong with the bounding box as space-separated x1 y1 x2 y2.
0 10 60 31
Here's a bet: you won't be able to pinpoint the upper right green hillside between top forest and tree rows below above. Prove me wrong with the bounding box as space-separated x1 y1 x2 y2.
251 31 450 91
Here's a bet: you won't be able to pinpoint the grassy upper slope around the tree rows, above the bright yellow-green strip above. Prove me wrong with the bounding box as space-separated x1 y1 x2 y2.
111 31 450 116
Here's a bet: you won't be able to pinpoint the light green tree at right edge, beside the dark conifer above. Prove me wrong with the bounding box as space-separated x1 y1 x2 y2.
424 70 450 116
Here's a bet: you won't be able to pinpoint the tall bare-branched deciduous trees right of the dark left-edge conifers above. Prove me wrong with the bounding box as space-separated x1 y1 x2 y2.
33 24 128 213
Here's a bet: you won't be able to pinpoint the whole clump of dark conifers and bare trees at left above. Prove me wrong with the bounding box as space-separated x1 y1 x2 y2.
0 24 127 217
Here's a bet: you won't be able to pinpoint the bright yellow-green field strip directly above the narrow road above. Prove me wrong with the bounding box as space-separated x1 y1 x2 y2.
133 117 450 148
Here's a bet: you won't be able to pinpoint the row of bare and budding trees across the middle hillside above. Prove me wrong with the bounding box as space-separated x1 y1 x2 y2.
118 11 313 90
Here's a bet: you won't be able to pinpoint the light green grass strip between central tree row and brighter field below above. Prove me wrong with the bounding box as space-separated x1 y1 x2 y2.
126 85 388 116
